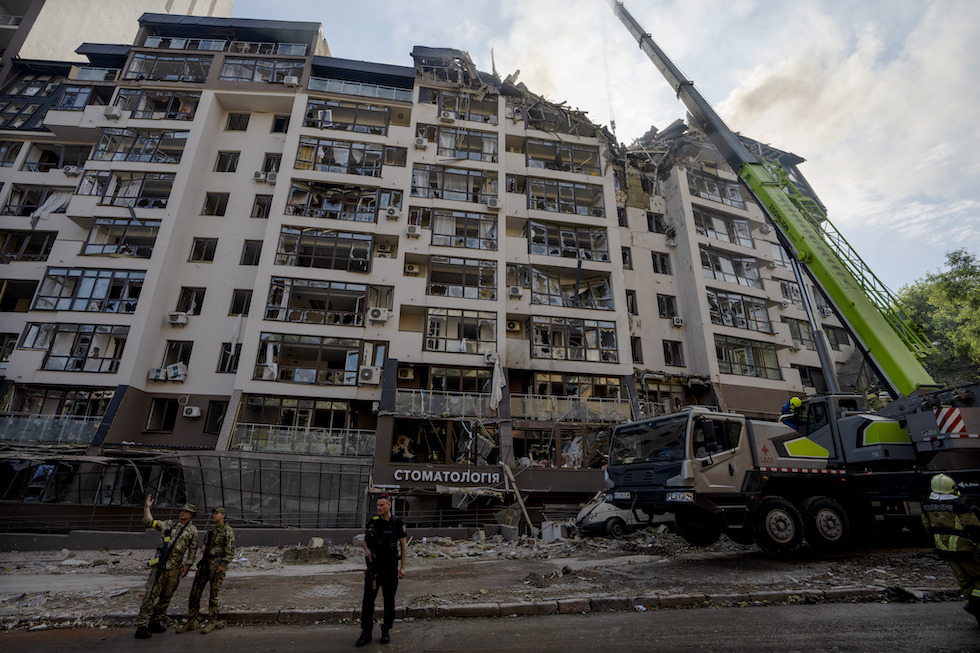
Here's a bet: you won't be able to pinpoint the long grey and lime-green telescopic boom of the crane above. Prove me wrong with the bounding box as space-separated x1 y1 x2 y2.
608 0 939 396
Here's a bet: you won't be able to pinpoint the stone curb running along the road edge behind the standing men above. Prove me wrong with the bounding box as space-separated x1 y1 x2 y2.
0 586 962 630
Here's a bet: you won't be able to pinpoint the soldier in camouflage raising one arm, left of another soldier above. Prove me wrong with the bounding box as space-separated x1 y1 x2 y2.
136 494 197 639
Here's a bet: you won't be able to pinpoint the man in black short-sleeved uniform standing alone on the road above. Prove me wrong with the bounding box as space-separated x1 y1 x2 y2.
355 494 408 646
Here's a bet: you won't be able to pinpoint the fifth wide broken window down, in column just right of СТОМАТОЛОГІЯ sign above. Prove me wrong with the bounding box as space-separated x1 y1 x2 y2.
531 316 619 363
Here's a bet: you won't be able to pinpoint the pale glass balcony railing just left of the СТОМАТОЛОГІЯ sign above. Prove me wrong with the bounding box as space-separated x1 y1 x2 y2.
228 422 376 457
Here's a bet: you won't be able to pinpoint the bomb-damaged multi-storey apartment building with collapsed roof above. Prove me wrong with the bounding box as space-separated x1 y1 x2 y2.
0 7 853 527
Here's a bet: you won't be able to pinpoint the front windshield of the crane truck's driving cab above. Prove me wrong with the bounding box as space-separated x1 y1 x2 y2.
609 413 690 465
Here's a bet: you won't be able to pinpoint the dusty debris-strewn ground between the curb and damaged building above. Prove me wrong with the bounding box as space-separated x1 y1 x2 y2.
0 527 955 628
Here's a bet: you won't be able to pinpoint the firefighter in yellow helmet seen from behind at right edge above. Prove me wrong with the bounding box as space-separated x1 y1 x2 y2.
922 474 980 624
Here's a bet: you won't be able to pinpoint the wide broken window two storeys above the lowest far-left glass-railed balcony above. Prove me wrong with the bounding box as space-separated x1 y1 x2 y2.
33 268 146 313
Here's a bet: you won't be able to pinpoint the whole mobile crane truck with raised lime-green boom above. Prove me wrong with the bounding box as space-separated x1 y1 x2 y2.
604 0 980 553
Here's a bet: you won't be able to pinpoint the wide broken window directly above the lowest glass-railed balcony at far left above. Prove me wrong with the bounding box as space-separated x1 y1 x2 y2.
21 322 129 372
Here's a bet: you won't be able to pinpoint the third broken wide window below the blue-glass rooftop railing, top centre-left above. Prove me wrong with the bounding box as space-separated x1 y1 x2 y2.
286 181 402 222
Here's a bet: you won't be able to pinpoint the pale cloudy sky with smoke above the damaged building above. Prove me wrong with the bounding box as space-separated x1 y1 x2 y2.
233 0 980 290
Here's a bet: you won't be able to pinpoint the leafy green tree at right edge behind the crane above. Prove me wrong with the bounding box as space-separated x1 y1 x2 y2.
898 249 980 384
